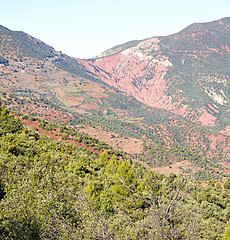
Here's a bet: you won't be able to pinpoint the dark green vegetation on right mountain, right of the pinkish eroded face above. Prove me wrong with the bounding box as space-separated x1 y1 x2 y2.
161 18 230 129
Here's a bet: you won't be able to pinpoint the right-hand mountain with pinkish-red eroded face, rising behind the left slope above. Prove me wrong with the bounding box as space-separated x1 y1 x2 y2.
78 18 230 133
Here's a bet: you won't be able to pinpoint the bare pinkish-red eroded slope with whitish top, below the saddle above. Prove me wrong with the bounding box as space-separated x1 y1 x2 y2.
77 36 217 127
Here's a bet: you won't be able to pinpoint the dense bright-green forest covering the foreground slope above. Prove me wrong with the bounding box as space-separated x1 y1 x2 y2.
0 99 230 240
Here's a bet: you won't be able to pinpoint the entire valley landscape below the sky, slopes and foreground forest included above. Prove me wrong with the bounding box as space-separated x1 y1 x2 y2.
0 18 230 240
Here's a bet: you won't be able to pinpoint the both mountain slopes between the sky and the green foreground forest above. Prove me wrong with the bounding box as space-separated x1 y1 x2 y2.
0 18 230 179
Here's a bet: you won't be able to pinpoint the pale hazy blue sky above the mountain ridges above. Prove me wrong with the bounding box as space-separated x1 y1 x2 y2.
0 0 230 58
